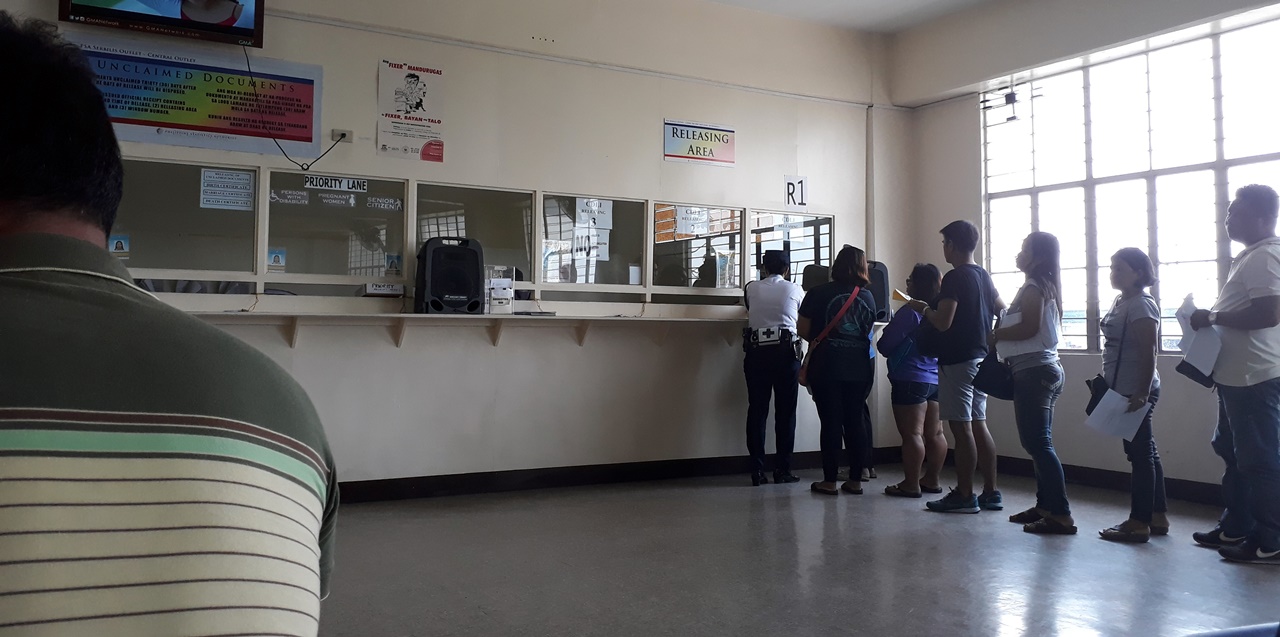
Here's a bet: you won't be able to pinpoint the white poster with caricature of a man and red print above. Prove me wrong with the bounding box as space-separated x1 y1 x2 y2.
378 60 444 162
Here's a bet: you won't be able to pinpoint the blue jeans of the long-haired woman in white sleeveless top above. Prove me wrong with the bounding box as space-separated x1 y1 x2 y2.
1014 362 1071 515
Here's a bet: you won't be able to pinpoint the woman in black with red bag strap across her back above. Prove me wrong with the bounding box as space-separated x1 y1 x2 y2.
796 246 876 495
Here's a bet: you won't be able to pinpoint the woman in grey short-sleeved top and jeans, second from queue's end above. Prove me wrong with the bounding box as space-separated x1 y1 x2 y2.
1098 248 1169 542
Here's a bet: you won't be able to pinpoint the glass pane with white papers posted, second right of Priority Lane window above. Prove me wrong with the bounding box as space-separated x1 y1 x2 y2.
541 194 645 285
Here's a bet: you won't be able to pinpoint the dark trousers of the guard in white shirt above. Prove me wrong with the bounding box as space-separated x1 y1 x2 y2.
742 344 800 473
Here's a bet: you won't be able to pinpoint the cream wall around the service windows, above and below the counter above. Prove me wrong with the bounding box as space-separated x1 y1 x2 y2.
0 0 892 481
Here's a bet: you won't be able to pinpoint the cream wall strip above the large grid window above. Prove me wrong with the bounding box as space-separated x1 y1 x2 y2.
890 0 1271 105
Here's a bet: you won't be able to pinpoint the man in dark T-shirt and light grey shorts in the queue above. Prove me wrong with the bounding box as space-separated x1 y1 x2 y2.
911 220 1005 513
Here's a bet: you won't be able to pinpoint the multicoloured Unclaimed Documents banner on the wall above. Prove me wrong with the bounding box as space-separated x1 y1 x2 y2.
67 32 323 155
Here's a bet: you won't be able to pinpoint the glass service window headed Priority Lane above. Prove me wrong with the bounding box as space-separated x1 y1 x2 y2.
266 173 406 278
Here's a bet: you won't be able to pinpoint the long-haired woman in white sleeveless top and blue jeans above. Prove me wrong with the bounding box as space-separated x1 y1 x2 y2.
991 233 1076 535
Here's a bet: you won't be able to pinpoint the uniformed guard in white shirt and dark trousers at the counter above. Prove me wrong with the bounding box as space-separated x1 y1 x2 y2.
742 249 804 486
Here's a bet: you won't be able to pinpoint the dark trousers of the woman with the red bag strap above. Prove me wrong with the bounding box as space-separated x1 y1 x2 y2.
809 380 869 482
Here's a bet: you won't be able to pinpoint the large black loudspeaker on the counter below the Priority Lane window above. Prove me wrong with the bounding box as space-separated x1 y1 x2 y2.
413 237 484 315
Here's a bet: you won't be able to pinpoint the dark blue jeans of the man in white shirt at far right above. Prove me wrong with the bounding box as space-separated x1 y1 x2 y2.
1213 379 1280 550
